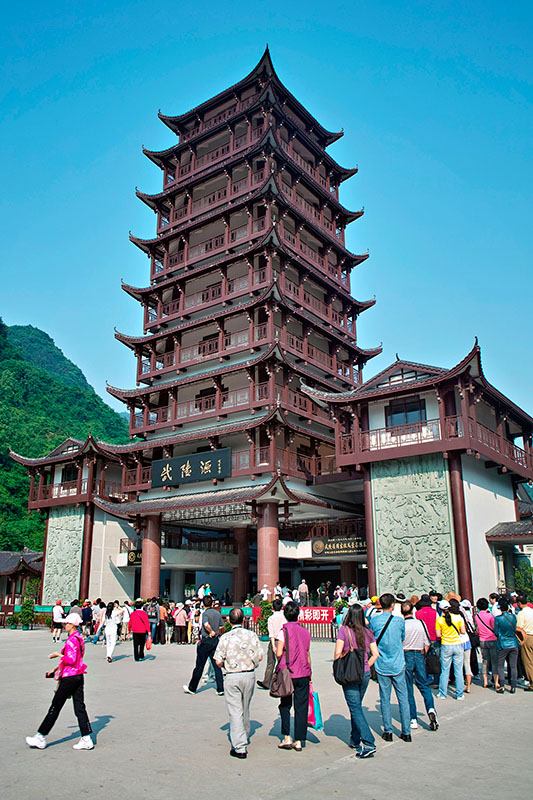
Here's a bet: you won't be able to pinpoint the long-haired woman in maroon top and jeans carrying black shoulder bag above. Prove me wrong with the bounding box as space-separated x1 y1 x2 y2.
333 604 379 758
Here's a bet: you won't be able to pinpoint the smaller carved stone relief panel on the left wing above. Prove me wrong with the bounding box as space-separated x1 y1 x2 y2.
42 506 85 606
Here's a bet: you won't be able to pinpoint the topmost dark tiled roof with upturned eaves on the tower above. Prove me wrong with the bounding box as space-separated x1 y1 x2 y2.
158 45 343 144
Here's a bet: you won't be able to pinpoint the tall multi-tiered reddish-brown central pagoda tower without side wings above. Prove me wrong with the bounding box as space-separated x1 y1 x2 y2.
104 48 380 599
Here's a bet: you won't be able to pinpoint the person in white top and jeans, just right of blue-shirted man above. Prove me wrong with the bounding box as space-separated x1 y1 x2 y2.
402 601 439 731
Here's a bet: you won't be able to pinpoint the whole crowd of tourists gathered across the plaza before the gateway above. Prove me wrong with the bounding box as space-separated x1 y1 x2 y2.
26 581 533 759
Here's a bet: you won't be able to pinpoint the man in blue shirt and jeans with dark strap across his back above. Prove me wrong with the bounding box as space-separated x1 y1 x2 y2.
369 592 412 742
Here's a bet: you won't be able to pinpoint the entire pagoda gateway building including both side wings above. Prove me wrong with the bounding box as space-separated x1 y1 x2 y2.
11 49 533 603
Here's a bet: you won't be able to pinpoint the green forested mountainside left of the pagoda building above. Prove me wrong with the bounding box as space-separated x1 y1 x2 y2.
0 319 128 550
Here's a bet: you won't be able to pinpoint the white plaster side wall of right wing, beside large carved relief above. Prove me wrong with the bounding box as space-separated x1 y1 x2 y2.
461 456 516 601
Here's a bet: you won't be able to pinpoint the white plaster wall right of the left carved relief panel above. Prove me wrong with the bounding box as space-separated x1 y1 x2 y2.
88 508 137 601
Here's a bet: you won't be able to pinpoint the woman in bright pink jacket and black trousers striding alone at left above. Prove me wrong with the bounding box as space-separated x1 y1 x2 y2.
26 614 94 750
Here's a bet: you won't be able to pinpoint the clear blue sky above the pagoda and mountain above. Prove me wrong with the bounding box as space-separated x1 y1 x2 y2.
0 0 533 413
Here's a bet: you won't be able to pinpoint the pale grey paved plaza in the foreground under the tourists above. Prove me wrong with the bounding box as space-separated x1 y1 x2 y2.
0 630 533 800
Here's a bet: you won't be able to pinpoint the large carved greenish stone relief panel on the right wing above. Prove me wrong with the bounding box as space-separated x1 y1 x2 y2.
371 453 457 597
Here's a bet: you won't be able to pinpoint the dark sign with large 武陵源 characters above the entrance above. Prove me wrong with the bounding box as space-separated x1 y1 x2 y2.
152 447 231 488
